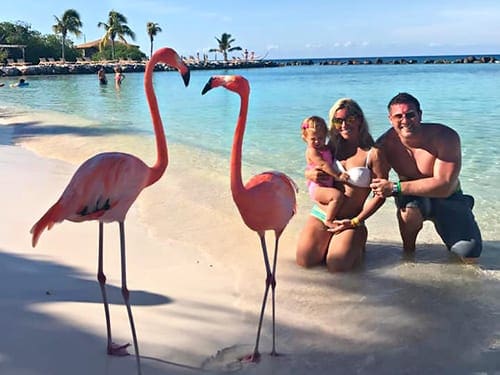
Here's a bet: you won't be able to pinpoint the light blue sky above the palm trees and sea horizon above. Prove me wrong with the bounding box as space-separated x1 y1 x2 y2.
0 0 500 59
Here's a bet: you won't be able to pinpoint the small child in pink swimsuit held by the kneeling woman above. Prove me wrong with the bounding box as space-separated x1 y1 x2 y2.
302 116 349 228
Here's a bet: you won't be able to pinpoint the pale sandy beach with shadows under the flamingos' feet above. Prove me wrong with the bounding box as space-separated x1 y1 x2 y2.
0 113 500 375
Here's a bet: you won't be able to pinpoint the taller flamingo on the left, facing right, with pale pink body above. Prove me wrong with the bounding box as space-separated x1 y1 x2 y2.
31 48 190 374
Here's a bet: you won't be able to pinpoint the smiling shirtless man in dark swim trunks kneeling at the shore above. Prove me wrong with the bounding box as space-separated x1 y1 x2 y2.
370 93 482 262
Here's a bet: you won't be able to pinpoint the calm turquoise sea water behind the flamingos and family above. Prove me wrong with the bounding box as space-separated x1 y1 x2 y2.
0 64 500 240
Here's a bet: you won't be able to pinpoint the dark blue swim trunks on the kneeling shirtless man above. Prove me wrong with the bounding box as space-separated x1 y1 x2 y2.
395 190 483 258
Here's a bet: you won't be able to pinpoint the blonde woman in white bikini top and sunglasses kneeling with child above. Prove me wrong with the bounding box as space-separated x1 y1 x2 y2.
296 98 384 272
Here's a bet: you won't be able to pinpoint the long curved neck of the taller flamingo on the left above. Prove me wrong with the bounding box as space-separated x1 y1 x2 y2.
144 55 168 185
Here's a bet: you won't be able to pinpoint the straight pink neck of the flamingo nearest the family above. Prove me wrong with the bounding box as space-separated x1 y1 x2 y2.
230 95 248 200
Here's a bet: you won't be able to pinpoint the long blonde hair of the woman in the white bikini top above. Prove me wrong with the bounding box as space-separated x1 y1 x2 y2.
328 98 375 150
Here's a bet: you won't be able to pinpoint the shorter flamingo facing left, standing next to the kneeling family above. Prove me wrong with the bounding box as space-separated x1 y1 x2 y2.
202 75 298 362
